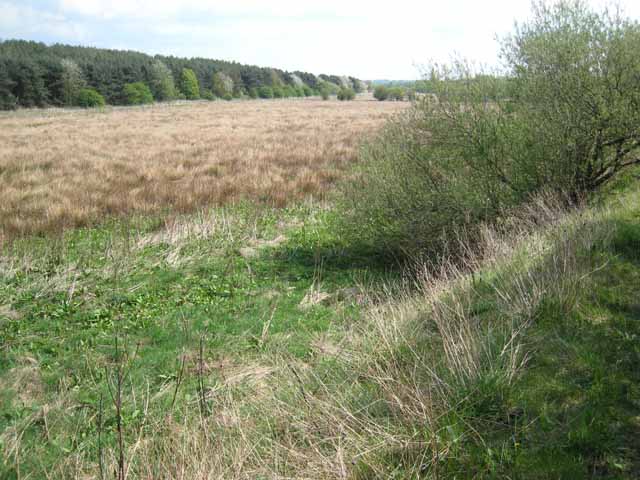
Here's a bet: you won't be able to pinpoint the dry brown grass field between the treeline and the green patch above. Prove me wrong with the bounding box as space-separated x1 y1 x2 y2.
0 99 406 242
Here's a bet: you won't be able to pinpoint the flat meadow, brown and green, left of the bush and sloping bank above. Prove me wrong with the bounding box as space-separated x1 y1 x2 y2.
0 97 407 478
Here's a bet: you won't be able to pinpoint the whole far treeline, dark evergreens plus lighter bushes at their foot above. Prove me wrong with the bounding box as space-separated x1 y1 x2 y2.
0 40 366 110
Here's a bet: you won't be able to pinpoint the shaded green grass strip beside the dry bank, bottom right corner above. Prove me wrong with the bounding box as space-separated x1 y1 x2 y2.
449 218 640 479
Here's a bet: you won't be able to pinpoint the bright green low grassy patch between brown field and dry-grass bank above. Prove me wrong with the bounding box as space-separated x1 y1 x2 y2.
0 204 394 478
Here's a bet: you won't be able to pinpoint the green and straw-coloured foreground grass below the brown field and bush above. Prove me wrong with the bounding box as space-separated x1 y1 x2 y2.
0 172 640 480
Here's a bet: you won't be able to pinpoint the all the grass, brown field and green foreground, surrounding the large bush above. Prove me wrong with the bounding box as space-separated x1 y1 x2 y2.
0 100 640 480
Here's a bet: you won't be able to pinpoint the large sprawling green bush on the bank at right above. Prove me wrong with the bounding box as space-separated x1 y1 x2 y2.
345 1 640 255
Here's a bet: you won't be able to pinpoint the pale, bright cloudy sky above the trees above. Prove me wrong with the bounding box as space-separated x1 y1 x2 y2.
0 0 640 80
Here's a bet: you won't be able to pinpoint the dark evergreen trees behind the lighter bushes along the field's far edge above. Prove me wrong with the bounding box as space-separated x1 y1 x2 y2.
0 40 362 109
